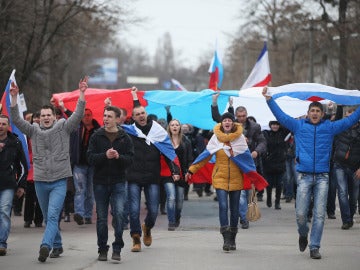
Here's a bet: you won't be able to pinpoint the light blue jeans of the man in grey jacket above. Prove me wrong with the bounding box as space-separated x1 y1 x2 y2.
35 178 67 249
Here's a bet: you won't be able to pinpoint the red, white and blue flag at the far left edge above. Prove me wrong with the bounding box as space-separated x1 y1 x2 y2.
1 69 30 168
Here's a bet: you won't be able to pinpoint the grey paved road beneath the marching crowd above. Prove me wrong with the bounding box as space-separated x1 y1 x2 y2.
0 193 360 270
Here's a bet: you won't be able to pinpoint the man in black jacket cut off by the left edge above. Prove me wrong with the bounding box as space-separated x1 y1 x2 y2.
0 114 28 256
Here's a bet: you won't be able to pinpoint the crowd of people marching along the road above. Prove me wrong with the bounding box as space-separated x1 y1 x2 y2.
0 83 360 262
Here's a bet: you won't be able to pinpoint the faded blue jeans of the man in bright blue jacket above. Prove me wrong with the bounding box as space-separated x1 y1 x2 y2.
296 172 329 250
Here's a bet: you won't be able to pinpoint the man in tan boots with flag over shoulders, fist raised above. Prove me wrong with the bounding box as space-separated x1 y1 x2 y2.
127 87 180 252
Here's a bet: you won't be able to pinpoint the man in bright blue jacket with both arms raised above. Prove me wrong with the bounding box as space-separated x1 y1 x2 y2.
262 87 360 259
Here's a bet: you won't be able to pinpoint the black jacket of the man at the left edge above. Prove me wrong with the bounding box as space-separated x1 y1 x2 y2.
0 131 28 190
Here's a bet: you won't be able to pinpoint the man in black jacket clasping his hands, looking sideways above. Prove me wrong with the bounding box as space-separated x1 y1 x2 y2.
87 106 134 261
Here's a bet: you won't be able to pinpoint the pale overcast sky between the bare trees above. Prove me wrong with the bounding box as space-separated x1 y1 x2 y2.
126 0 243 67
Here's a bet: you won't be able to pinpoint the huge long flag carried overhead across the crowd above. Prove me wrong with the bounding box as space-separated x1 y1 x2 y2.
53 83 360 130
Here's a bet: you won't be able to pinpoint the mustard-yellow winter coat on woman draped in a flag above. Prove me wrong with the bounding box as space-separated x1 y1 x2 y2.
189 123 243 191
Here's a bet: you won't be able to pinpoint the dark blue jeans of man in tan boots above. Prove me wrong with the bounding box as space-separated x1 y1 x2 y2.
128 182 160 235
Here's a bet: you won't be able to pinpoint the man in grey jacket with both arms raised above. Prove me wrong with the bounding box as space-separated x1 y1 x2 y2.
10 77 88 262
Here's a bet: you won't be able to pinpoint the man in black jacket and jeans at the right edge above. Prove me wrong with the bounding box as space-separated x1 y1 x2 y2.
333 108 360 230
